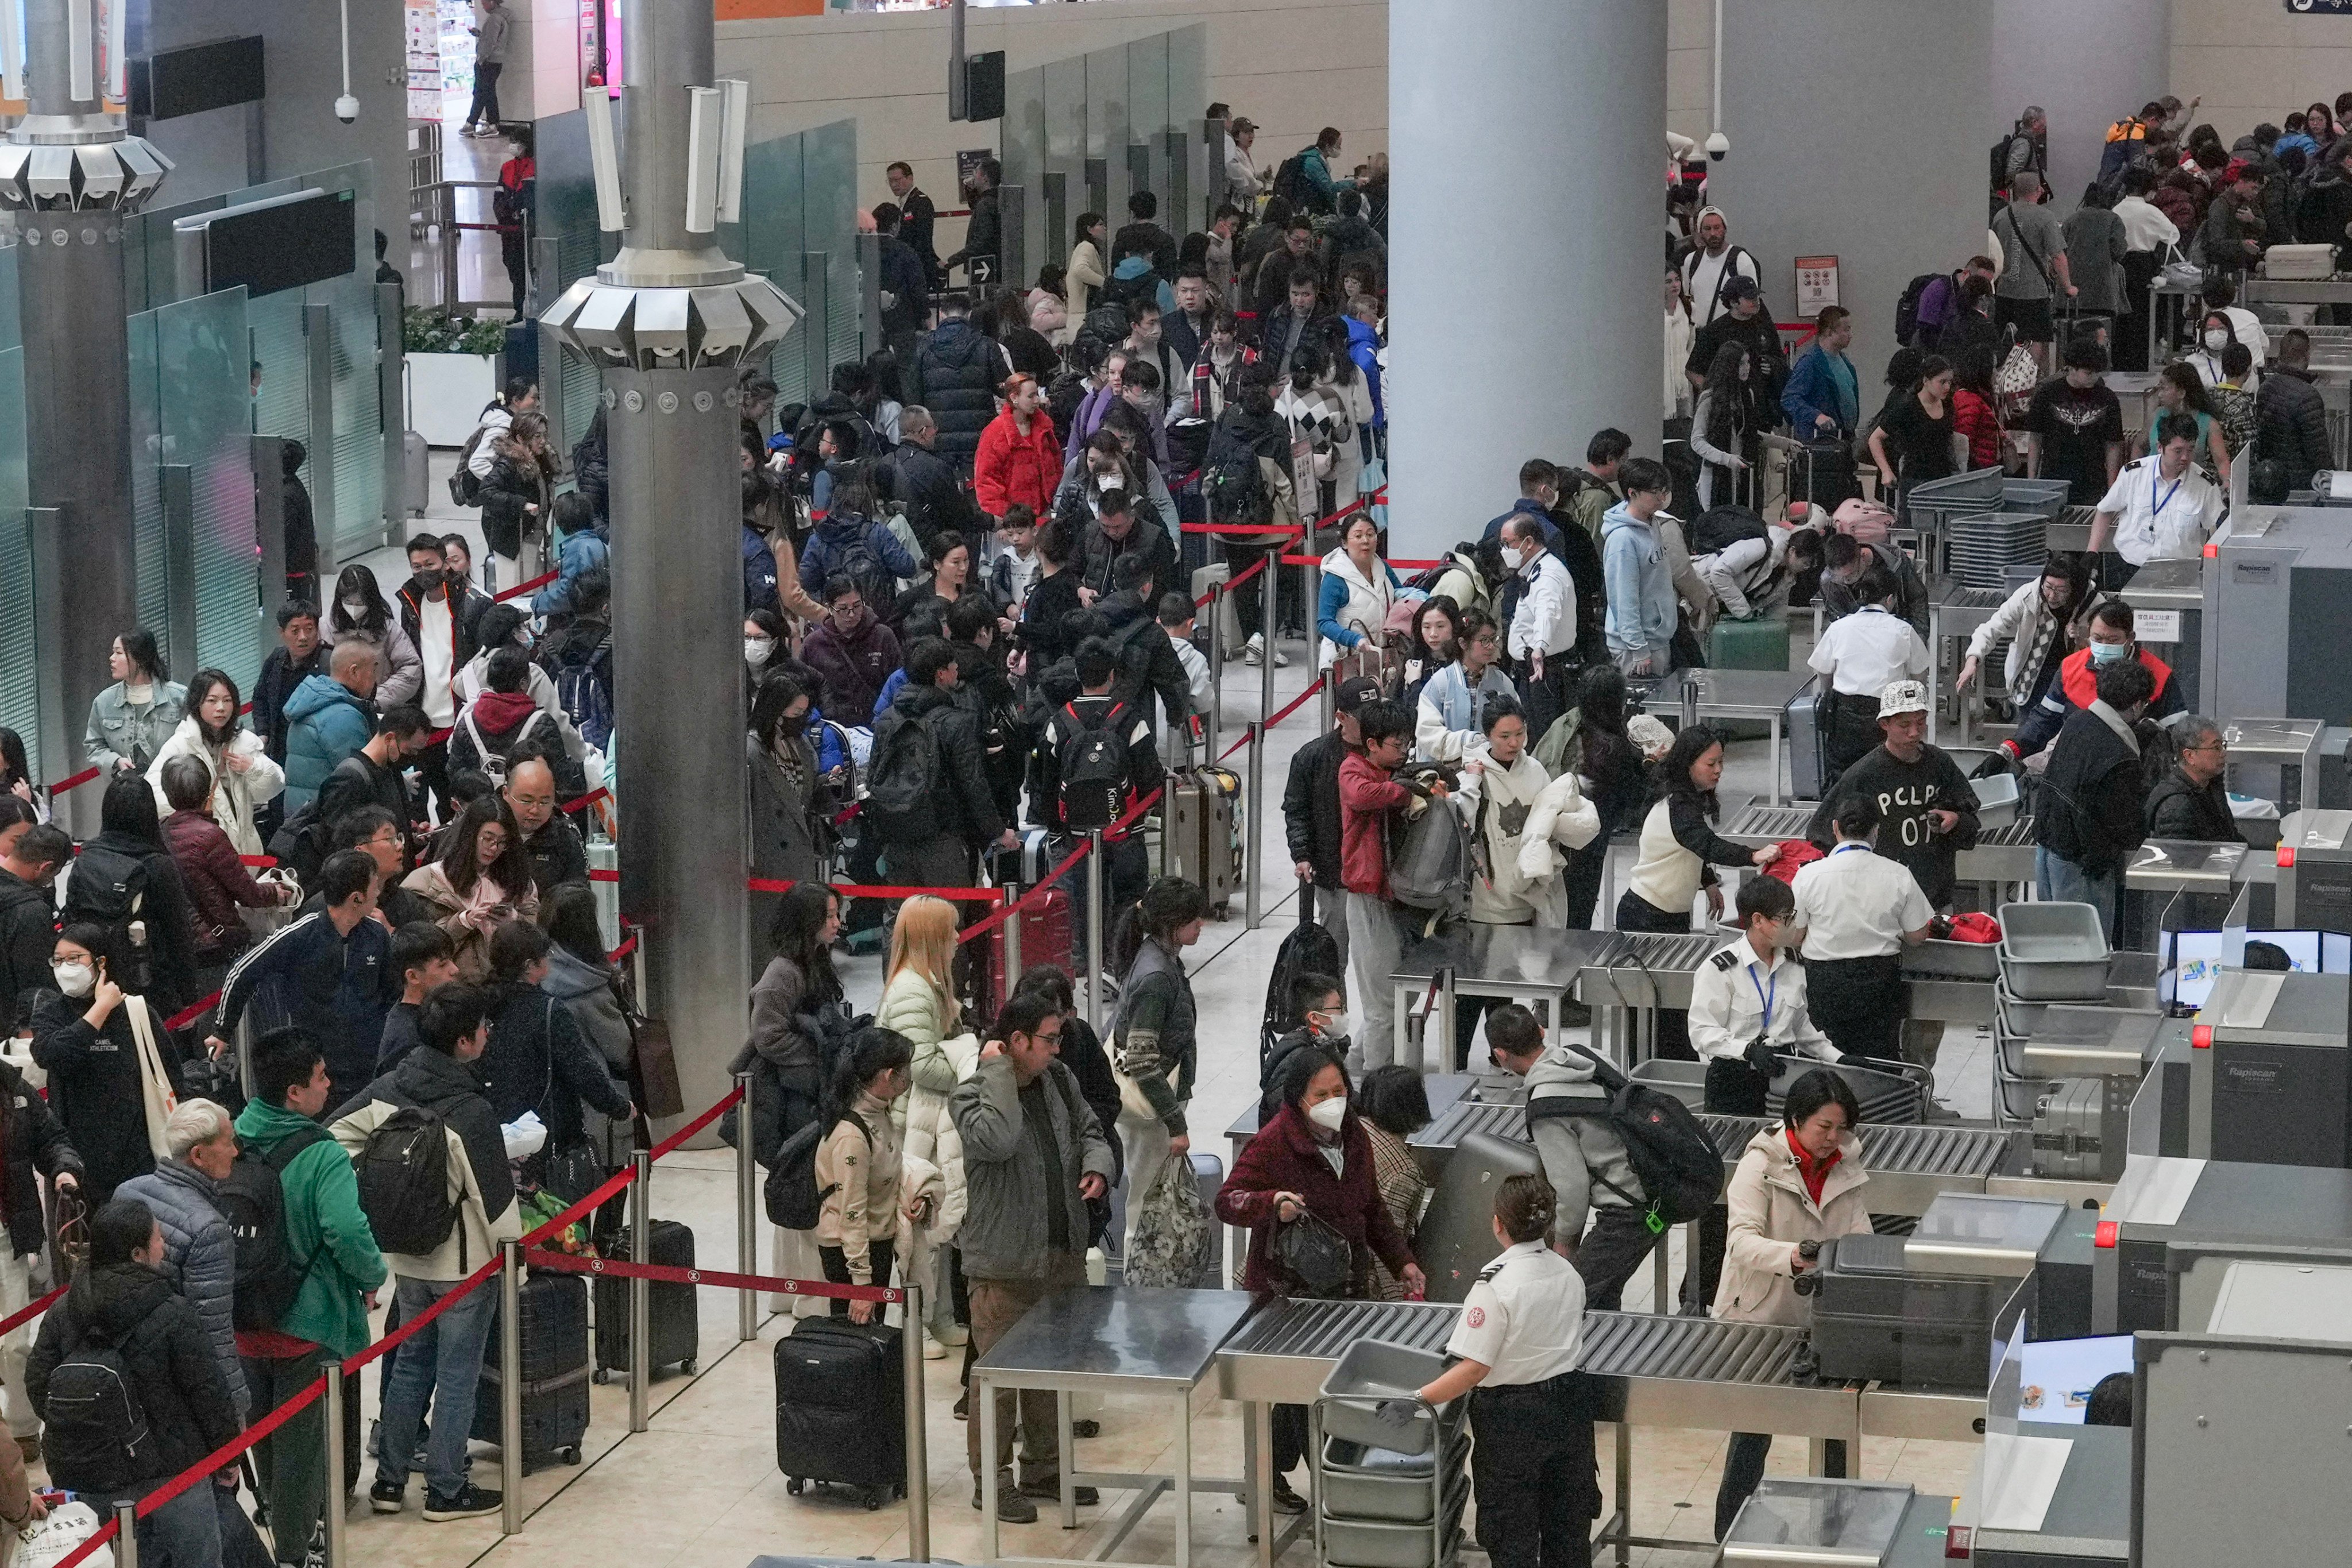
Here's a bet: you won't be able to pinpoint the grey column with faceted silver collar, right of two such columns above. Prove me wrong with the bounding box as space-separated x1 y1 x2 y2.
543 0 800 1128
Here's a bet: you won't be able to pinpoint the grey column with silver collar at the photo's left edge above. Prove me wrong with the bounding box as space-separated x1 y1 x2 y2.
0 0 168 830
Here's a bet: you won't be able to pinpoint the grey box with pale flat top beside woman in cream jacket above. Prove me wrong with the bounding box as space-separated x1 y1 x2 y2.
1811 1192 2065 1389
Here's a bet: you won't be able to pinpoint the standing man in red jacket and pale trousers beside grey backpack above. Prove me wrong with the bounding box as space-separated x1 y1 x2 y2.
1338 701 1430 1074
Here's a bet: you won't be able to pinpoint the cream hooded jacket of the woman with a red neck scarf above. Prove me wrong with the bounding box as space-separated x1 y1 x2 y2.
1714 1126 1870 1328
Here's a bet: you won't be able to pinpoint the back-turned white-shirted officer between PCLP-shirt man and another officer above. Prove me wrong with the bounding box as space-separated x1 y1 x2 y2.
1794 794 1936 1063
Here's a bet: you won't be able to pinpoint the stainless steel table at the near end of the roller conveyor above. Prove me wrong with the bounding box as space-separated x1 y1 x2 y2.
971 1286 1249 1568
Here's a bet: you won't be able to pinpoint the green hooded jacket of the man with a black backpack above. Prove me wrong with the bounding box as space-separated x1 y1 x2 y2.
238 1091 385 1357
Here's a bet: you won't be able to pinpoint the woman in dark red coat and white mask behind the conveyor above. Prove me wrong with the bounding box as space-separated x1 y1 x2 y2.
1216 1051 1428 1514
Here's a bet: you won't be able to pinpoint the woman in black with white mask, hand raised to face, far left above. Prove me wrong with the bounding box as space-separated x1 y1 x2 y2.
33 924 179 1208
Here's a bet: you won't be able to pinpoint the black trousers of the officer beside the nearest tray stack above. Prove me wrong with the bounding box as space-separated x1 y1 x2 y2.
1470 1373 1602 1568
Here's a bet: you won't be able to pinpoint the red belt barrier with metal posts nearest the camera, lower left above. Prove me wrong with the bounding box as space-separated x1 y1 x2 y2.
25 1044 932 1568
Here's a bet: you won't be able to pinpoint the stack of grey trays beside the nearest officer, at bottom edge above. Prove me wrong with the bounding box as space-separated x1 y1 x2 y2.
1312 1340 1470 1568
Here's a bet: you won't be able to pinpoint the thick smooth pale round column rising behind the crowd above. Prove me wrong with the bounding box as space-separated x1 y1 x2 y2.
1388 0 1665 557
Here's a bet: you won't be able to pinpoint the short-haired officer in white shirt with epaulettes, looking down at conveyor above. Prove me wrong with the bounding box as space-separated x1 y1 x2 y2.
1691 877 1839 1117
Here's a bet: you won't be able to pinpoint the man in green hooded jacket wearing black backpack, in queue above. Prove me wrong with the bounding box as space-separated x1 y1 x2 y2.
238 1030 386 1568
